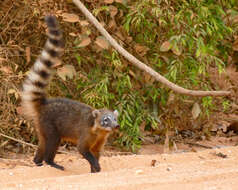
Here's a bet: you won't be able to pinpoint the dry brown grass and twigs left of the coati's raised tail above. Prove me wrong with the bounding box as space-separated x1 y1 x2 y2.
0 0 69 153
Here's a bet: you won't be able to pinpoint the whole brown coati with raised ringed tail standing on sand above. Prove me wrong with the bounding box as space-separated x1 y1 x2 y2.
21 15 119 172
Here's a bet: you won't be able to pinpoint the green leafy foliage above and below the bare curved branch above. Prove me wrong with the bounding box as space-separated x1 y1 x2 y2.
70 0 236 150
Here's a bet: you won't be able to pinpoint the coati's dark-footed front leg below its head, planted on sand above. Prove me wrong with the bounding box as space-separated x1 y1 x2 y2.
78 138 101 173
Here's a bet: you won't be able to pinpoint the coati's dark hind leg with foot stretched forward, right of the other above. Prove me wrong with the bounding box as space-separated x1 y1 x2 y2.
44 131 64 170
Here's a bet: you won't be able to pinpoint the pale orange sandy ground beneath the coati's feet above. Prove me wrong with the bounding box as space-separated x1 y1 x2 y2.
0 139 238 190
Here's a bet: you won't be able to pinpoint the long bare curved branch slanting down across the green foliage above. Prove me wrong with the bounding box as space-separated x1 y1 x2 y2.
73 0 230 97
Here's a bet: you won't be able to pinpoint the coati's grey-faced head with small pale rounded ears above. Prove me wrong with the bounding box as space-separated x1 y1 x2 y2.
92 109 120 131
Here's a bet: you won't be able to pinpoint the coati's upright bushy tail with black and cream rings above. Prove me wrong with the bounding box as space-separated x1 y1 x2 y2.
21 16 64 117
